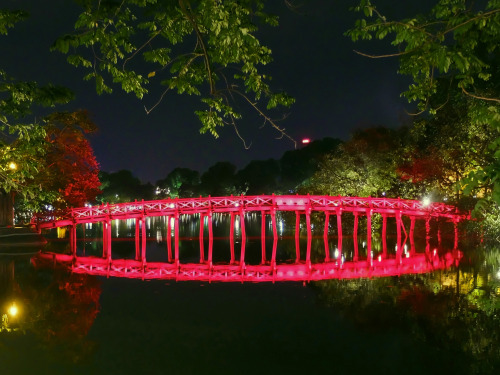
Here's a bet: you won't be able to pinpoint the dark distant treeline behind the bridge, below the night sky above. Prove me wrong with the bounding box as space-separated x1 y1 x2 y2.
97 138 342 203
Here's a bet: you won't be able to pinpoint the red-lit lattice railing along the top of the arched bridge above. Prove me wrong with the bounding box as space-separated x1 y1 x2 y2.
32 194 468 225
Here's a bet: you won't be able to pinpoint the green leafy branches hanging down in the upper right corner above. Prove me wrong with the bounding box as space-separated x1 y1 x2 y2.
348 0 500 206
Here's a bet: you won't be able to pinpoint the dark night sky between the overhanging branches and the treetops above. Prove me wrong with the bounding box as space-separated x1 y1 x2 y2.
0 0 429 183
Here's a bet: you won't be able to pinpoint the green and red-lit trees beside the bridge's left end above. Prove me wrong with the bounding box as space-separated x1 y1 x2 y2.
0 10 99 225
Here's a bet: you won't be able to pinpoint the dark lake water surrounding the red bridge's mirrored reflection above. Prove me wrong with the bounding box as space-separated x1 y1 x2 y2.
0 217 500 375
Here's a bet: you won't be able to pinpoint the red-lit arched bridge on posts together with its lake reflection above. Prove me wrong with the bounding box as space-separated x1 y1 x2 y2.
33 195 468 282
